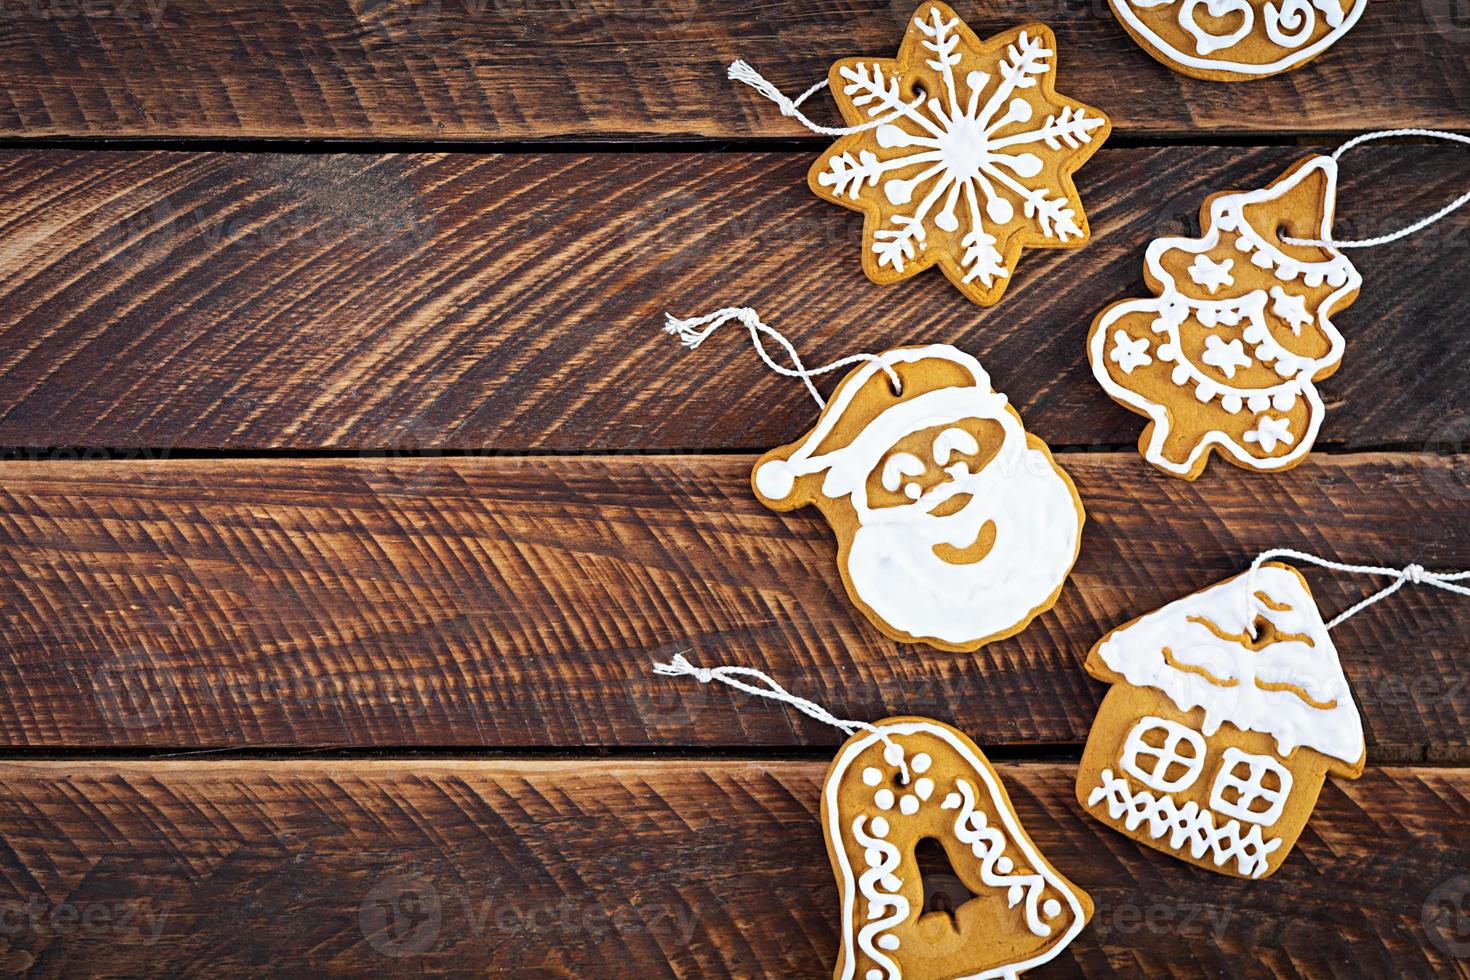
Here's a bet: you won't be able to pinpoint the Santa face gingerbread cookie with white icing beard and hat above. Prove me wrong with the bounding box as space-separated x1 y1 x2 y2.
751 344 1083 651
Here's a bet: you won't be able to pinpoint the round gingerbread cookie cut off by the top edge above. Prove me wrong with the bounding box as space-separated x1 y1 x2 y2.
1108 0 1369 82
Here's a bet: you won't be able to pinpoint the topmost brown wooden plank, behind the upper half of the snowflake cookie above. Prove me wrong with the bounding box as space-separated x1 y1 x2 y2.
0 0 1470 140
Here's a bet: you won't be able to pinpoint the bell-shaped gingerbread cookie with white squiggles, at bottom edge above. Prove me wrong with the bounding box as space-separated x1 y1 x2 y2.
822 718 1092 980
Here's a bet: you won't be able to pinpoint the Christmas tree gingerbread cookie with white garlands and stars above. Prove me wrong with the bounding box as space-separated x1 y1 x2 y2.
1088 157 1363 480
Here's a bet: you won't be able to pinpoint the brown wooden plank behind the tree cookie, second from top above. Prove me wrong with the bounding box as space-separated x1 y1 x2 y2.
0 144 1470 451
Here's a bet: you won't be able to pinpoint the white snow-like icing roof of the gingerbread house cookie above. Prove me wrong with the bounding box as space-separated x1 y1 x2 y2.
1094 564 1363 765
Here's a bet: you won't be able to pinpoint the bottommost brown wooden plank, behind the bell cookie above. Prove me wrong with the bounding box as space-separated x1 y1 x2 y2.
0 760 1470 977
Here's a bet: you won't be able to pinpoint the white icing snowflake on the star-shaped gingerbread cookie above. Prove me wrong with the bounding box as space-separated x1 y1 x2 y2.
817 15 1107 287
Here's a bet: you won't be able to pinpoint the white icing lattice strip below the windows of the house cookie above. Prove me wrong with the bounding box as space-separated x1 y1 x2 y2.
1088 768 1282 877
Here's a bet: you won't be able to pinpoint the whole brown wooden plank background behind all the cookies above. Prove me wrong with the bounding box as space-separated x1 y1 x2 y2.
0 0 1470 979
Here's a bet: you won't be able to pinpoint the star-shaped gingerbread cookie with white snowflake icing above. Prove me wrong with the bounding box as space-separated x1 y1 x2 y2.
807 3 1110 306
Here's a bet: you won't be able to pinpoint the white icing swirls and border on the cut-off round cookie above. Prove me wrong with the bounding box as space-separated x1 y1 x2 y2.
1113 0 1369 75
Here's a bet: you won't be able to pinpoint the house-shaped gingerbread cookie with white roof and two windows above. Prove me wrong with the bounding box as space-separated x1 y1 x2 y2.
1078 563 1366 879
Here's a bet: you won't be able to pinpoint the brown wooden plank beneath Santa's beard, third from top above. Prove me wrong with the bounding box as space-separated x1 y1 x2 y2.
0 453 1470 761
